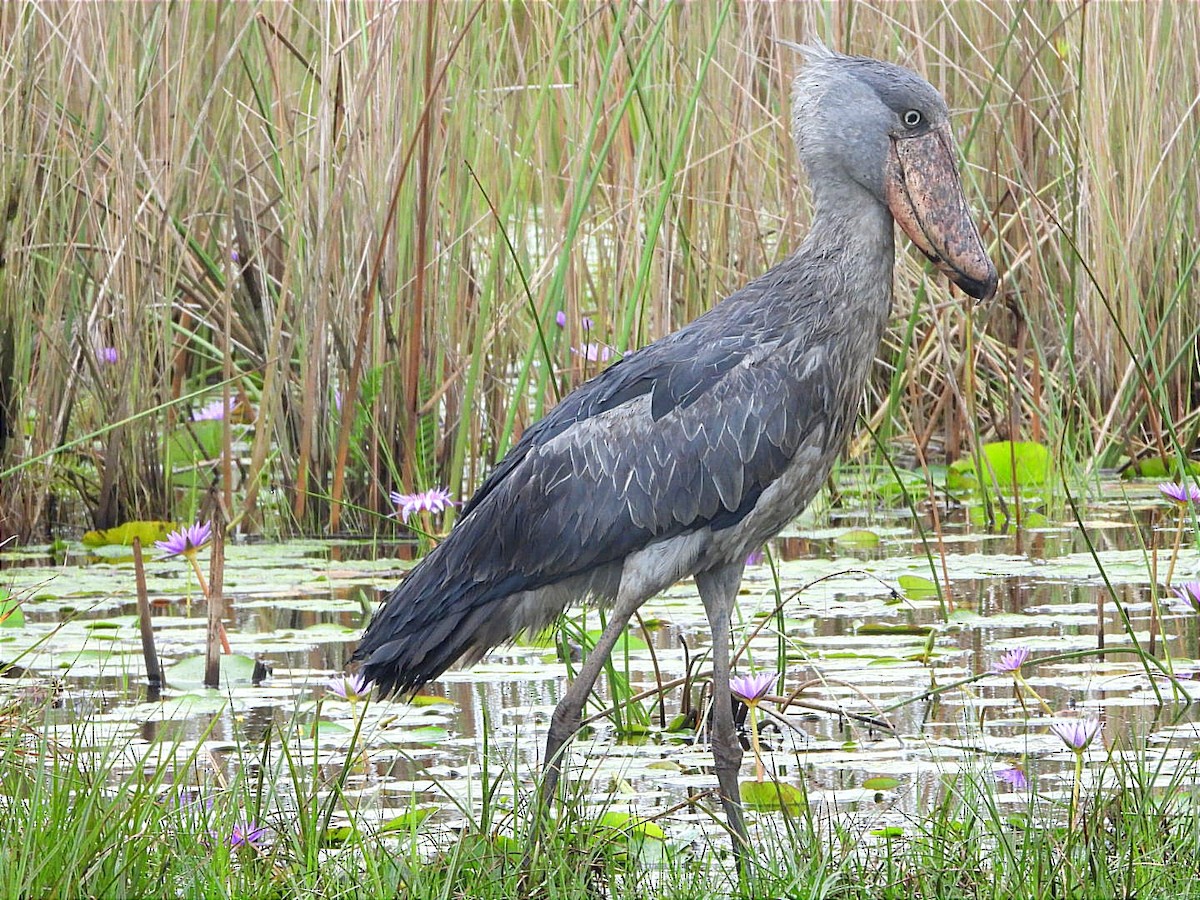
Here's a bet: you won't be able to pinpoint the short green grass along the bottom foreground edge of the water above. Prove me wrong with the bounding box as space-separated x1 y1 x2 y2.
7 681 1200 900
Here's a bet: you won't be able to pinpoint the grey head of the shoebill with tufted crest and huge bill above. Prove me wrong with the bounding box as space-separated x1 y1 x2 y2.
792 44 997 300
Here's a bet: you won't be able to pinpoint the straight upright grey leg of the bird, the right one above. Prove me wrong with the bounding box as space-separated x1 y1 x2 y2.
696 563 750 870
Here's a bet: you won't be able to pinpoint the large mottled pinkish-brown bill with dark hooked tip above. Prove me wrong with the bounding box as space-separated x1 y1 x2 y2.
883 125 998 300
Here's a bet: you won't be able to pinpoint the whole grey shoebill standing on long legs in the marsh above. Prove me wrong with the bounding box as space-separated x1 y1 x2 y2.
352 42 998 860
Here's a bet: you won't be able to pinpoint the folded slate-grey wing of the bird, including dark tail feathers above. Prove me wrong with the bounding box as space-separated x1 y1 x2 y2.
355 326 830 691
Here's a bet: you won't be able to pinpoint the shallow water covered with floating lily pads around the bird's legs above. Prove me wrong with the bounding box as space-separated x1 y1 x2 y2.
0 484 1200 840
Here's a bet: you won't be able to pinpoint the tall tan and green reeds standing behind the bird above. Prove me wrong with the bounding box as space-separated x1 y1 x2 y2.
0 2 1200 535
